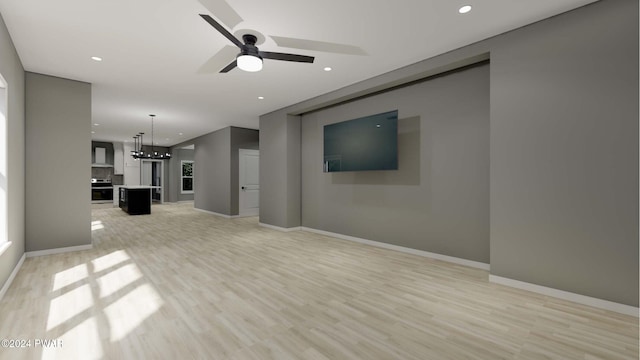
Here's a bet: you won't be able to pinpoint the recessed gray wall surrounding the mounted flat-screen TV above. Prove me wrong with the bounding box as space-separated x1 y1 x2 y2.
302 63 489 263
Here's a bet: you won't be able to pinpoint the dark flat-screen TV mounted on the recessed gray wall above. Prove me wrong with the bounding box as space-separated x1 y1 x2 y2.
324 110 398 172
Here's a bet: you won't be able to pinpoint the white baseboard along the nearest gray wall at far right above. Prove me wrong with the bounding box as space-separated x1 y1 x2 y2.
489 275 639 317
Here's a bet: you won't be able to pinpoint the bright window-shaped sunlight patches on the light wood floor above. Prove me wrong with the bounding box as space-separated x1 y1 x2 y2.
42 248 164 352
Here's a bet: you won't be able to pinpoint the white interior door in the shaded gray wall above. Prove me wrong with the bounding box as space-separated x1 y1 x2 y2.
238 149 260 216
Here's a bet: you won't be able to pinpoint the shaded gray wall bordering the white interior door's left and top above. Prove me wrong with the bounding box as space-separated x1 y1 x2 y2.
229 127 260 215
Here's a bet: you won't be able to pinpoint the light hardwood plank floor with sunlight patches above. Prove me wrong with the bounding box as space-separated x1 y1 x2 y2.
0 203 638 360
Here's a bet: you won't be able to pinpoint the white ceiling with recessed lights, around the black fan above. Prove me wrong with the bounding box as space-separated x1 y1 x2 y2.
0 0 594 146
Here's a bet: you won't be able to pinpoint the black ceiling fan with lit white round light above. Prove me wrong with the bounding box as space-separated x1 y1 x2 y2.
200 14 315 73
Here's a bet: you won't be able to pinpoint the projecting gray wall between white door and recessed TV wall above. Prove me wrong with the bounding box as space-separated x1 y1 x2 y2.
260 111 301 228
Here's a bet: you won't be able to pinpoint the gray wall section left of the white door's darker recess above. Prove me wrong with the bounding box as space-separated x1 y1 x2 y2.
192 128 231 215
